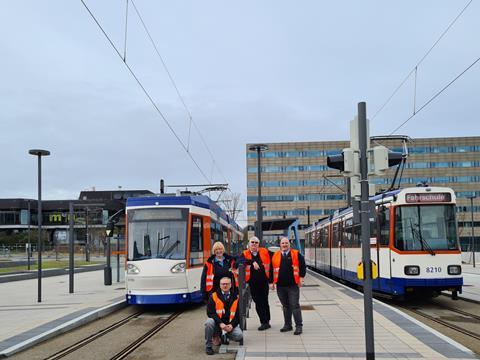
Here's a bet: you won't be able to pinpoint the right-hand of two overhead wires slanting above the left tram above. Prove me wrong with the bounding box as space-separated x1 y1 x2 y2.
130 0 230 191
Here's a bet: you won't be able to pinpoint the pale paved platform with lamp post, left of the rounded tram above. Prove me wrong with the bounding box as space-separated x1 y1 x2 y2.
0 270 126 357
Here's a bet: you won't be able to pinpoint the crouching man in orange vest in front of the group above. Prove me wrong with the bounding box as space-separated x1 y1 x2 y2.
205 277 243 355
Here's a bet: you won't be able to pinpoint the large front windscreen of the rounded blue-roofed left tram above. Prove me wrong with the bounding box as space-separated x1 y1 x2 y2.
128 208 188 260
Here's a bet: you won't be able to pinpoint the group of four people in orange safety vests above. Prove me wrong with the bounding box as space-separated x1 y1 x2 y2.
201 236 306 355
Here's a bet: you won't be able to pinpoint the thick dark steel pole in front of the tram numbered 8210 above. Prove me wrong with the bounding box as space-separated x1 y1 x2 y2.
358 102 375 360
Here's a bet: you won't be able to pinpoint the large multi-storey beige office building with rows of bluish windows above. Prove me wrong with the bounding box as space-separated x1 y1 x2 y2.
246 136 480 251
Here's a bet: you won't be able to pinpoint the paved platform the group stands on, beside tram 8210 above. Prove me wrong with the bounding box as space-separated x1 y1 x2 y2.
234 272 477 360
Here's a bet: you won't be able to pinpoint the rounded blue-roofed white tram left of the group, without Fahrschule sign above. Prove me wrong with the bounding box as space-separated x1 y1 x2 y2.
125 195 243 304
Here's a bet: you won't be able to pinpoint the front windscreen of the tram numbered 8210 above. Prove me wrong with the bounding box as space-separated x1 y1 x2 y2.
395 205 459 253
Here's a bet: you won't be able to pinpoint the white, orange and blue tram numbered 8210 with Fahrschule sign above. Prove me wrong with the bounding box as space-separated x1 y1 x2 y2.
305 187 463 298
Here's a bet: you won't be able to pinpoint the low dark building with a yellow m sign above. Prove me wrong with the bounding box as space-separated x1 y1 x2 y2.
0 190 153 250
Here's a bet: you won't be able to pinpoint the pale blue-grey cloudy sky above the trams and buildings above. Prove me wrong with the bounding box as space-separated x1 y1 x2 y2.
0 0 480 225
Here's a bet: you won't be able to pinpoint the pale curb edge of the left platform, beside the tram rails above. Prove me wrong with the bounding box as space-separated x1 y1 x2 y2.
0 300 127 358
